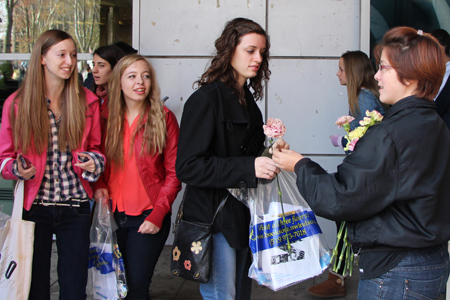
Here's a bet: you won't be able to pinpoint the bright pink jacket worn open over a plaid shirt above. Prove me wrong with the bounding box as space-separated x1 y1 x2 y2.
0 89 103 210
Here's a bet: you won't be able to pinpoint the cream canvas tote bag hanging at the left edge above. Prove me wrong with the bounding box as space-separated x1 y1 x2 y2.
0 158 34 300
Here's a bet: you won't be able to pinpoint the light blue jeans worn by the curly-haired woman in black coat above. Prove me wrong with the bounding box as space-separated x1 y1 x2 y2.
200 233 252 300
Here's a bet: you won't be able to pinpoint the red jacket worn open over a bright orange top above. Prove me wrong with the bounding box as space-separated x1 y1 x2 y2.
93 107 181 228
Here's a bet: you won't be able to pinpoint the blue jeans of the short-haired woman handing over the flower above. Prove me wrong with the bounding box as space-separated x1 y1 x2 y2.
358 245 449 300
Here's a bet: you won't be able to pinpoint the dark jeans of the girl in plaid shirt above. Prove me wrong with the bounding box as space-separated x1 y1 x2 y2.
23 202 91 300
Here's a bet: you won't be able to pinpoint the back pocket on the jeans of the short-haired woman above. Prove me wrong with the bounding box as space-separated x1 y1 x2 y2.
405 276 443 300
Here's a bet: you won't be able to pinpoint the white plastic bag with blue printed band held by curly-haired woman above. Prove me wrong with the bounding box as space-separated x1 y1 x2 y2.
230 170 331 291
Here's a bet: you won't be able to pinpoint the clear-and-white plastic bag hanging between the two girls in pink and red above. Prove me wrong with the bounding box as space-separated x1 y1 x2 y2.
88 200 128 300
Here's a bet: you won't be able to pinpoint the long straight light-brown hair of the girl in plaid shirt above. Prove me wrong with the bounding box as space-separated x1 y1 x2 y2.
10 29 86 154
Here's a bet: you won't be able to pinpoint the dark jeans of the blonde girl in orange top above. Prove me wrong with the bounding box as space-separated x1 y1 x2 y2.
114 209 170 300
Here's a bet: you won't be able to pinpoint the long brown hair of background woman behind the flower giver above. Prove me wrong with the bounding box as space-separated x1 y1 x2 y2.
341 51 380 116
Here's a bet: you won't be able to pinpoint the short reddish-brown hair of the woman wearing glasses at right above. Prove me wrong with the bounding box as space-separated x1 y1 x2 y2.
374 27 446 101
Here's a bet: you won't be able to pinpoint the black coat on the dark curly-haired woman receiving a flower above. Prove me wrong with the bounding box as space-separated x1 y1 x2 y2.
176 82 265 249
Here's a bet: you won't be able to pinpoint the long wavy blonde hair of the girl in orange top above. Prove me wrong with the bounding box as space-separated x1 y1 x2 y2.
105 54 166 167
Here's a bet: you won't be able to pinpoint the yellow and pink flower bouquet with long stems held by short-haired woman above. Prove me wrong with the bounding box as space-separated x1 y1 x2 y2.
331 110 383 276
